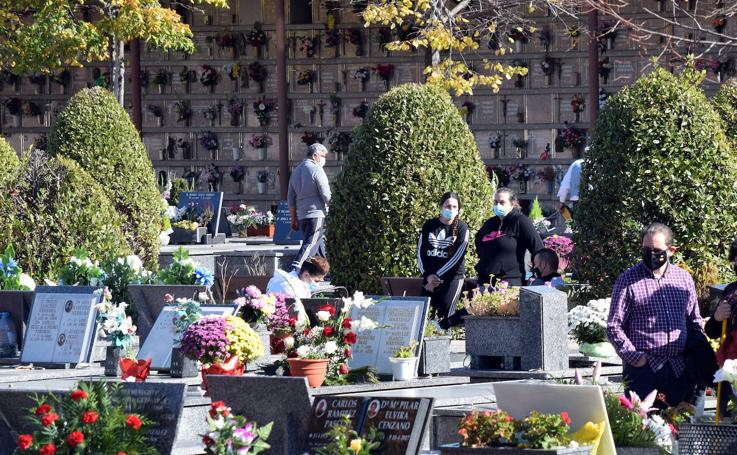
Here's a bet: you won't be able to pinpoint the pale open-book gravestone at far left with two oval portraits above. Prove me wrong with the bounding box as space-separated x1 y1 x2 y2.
21 286 100 364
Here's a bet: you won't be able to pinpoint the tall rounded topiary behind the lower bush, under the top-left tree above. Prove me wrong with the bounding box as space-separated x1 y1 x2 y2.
49 87 161 267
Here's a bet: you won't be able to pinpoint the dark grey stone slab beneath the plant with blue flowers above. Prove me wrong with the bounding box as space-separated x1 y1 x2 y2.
128 284 207 344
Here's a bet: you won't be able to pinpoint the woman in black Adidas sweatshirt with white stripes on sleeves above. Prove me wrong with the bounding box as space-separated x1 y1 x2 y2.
417 192 468 320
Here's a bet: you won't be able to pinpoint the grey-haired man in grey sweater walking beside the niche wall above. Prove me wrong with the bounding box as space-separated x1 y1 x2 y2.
287 143 330 270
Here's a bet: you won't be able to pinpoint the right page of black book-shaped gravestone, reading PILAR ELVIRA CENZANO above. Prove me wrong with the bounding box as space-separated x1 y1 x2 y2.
359 397 433 455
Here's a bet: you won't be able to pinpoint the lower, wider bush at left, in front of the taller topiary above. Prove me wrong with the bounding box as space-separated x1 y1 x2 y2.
0 151 130 280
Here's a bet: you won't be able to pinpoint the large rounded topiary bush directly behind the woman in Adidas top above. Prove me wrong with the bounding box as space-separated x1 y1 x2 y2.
327 84 493 293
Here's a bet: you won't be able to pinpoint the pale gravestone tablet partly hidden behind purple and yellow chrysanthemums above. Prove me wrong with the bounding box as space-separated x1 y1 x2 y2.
136 305 235 370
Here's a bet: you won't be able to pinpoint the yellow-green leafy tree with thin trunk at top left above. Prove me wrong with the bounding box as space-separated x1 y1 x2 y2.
0 0 228 104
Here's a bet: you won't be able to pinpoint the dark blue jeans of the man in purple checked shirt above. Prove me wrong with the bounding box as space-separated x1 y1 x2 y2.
623 362 693 409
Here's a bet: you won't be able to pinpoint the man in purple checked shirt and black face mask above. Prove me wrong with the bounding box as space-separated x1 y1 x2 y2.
607 223 703 408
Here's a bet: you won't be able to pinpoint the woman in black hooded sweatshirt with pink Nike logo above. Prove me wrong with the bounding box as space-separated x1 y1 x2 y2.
475 188 544 286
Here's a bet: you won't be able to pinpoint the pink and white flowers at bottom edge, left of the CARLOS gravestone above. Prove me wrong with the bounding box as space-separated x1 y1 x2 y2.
202 401 273 455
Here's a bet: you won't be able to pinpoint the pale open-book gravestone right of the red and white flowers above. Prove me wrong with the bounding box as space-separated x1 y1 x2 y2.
349 296 430 375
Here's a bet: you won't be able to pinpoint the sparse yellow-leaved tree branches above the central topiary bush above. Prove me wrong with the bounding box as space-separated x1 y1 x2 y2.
352 0 579 95
